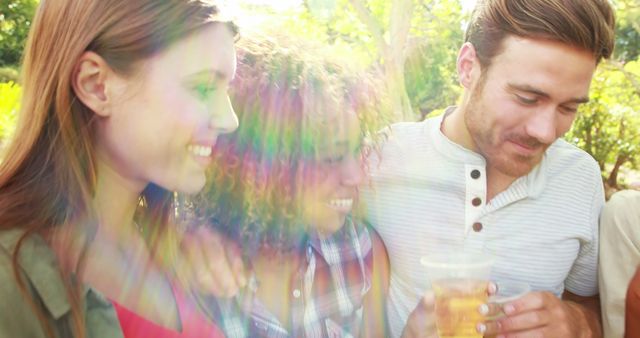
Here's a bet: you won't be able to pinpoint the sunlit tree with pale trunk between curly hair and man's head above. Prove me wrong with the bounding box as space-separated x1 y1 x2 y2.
288 0 464 120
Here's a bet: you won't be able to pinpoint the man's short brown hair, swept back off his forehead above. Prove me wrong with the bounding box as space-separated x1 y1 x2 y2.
465 0 615 68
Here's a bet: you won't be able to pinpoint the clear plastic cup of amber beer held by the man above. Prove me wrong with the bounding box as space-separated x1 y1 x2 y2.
421 252 493 338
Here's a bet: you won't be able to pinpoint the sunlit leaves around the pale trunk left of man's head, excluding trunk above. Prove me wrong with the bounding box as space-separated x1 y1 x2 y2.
286 0 465 120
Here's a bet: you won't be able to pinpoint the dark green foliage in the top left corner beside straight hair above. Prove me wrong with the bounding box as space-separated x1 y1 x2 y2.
0 0 39 67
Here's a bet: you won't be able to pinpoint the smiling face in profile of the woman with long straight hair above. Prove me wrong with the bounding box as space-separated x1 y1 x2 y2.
97 24 238 193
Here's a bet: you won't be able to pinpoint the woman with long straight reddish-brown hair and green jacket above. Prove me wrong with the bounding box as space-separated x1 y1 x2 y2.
0 0 237 337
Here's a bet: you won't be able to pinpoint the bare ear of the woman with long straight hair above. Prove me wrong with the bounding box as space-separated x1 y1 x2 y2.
71 52 113 117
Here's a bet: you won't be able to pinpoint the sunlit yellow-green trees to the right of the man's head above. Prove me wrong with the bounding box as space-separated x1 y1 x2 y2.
566 0 640 191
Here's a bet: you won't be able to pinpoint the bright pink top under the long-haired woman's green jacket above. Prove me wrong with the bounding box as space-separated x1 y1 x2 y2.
111 286 224 338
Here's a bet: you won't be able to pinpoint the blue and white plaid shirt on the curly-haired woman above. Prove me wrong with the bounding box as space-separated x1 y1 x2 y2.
210 218 372 338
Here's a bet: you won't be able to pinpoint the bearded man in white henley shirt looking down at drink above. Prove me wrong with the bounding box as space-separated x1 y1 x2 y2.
362 0 614 337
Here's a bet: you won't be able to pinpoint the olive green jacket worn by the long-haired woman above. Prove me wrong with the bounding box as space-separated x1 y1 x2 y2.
0 230 122 338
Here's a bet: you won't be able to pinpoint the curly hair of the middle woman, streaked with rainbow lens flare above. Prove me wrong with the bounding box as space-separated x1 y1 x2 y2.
192 34 387 257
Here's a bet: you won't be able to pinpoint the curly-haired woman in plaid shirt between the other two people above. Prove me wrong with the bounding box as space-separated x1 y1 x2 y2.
193 35 387 337
